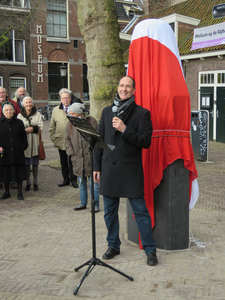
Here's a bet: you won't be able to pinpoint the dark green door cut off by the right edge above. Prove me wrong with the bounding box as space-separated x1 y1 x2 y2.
216 87 225 143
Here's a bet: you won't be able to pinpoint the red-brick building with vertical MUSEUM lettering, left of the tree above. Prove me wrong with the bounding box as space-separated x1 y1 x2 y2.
0 0 88 107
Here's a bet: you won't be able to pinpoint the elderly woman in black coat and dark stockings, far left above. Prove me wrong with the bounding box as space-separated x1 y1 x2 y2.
0 102 28 200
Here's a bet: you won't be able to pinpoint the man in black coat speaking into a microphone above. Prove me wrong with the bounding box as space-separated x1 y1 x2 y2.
94 76 158 266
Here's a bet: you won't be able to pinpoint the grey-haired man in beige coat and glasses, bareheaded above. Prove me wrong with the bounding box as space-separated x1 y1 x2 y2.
49 89 81 188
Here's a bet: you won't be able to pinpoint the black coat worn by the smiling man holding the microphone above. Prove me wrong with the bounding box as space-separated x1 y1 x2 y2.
93 104 152 198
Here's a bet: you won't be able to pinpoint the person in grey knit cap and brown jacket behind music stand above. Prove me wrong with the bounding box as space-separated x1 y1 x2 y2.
66 103 99 212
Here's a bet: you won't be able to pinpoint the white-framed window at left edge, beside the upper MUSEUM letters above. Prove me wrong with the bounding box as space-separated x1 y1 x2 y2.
0 30 25 62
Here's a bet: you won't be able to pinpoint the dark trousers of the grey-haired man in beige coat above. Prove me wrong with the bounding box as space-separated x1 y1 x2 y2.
58 149 77 182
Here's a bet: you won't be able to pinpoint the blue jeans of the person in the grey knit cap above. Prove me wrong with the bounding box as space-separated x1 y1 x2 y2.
78 176 99 206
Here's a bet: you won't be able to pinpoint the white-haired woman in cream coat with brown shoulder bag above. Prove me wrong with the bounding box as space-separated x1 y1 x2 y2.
17 97 43 191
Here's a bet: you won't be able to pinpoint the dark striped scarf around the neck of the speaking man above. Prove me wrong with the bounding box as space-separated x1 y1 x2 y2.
113 94 135 122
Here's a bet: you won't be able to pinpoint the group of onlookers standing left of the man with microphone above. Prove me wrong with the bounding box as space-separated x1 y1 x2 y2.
0 87 99 212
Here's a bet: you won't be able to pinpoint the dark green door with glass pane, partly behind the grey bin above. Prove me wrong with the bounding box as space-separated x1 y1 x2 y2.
200 87 214 141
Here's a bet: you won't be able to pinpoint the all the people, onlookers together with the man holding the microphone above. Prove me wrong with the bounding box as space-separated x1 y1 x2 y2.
0 76 158 266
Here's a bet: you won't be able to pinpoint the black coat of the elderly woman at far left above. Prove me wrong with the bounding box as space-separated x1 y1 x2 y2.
0 116 28 166
